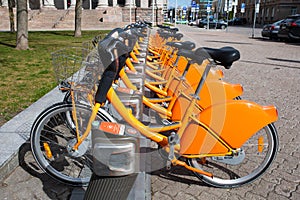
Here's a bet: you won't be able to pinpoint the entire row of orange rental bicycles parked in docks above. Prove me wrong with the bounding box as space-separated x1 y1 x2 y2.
31 22 278 188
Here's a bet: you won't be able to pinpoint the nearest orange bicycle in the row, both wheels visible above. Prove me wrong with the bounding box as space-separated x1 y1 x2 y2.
31 24 278 188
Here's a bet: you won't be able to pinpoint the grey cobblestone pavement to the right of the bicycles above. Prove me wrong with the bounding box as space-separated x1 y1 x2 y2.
151 25 300 200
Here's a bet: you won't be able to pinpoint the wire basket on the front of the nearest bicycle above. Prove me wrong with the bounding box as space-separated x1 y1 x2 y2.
52 47 103 103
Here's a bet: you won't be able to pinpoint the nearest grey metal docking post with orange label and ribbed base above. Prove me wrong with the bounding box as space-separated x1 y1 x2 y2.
84 121 151 200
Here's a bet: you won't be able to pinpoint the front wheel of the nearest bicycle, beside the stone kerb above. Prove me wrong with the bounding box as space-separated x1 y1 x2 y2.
30 102 113 186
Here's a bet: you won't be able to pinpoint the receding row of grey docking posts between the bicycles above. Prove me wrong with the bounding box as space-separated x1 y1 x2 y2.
84 27 150 200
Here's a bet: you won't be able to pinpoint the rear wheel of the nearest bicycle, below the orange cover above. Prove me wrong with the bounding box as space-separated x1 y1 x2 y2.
188 124 278 188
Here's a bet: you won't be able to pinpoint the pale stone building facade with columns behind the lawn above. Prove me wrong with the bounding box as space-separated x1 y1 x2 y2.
0 0 167 24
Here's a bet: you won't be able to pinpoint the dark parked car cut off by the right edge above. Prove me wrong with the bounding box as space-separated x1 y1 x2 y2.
278 14 300 40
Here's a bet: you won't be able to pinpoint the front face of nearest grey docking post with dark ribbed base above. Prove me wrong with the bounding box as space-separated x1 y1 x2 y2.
84 121 140 200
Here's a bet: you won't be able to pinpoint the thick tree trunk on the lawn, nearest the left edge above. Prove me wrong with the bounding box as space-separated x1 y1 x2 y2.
16 0 29 50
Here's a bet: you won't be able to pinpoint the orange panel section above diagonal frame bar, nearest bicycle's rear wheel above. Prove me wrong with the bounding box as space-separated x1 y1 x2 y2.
199 100 278 148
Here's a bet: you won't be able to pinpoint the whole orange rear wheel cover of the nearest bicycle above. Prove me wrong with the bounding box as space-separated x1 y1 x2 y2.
180 100 278 155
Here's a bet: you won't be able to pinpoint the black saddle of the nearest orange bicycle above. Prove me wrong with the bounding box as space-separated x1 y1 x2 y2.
195 47 240 69
